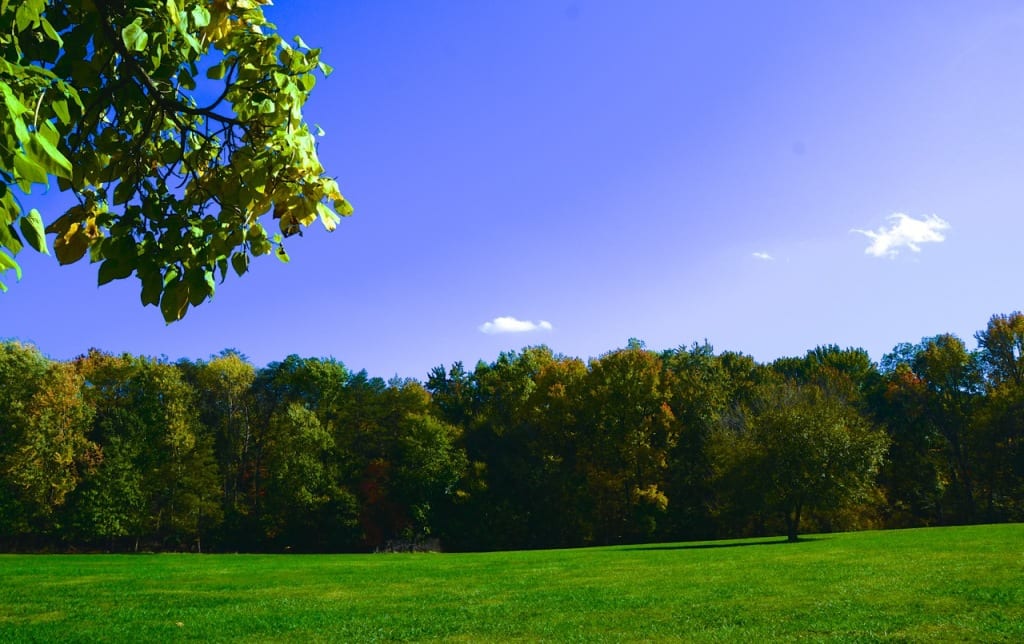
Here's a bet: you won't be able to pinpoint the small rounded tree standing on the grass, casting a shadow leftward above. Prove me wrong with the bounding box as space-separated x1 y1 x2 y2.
714 383 889 542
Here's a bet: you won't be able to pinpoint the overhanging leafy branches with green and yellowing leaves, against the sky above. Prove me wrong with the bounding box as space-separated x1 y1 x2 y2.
0 0 351 321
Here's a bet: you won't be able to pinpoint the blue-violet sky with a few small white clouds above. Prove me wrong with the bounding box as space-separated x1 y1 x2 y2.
6 0 1024 379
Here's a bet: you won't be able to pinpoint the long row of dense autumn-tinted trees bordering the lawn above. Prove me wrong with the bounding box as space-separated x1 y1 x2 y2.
0 312 1024 552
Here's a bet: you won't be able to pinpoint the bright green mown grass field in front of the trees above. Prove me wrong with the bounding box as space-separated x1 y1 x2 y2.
0 524 1024 642
